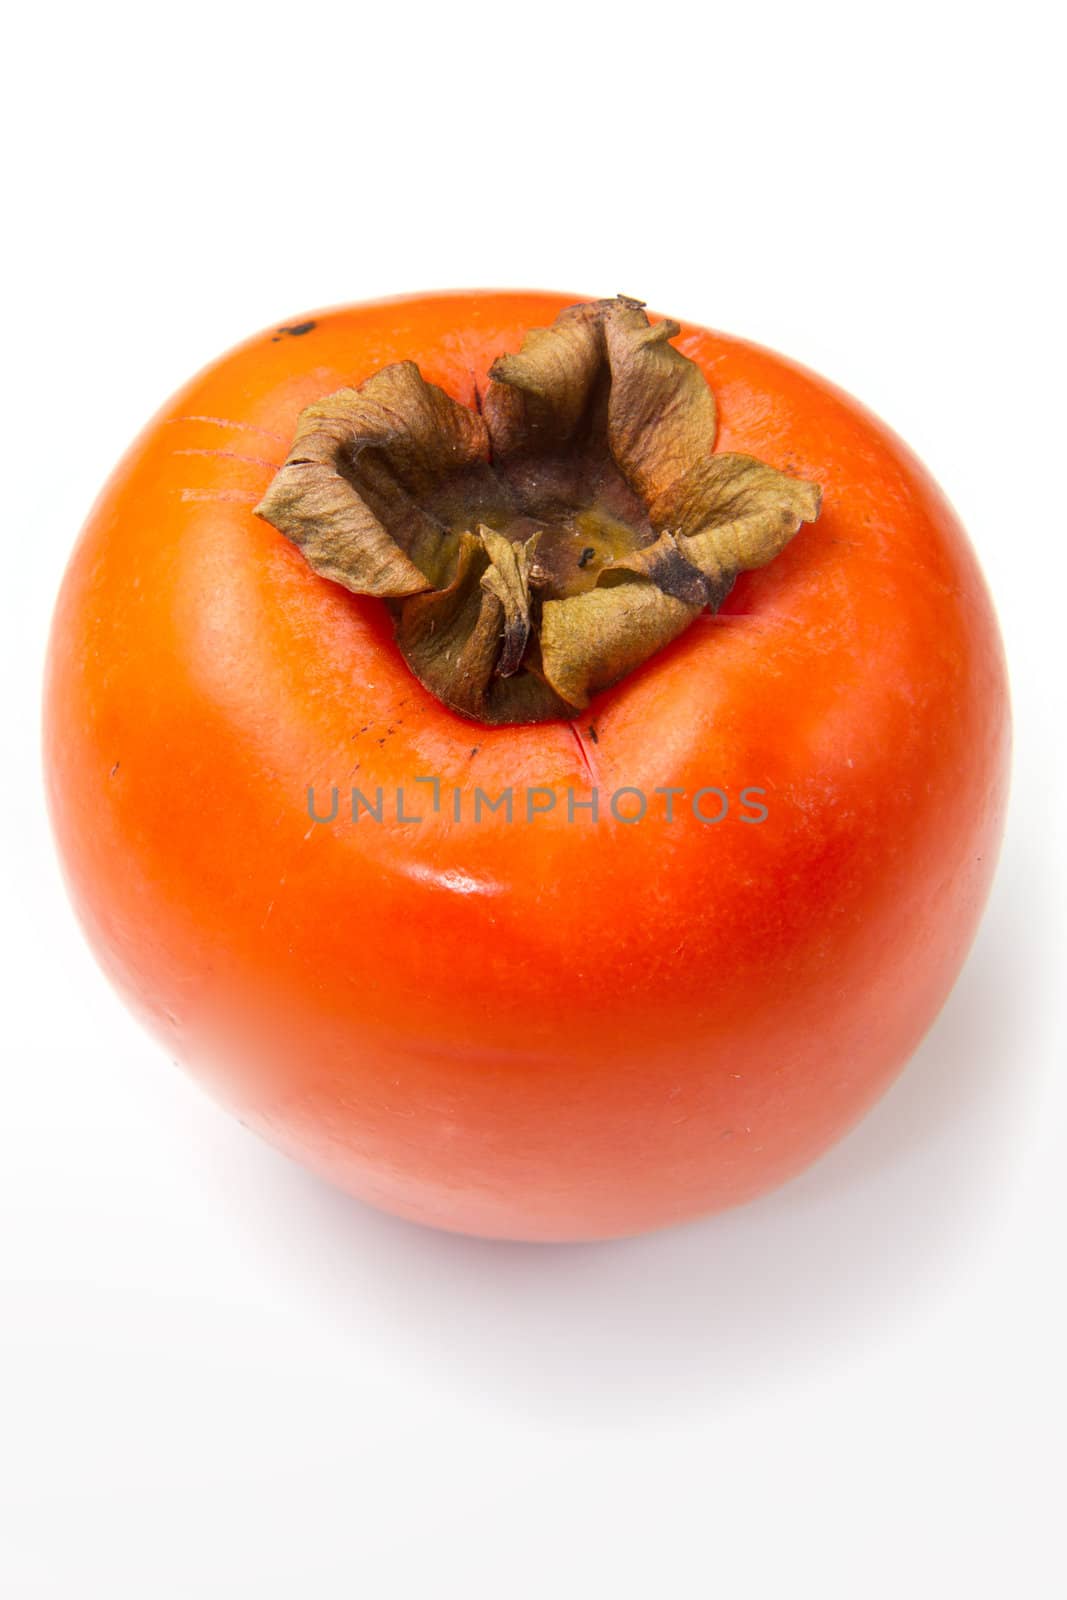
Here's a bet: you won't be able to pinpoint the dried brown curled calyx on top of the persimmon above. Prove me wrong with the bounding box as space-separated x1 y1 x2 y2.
256 298 821 723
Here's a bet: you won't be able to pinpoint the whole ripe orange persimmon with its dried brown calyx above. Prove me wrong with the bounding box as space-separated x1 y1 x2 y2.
45 291 1009 1240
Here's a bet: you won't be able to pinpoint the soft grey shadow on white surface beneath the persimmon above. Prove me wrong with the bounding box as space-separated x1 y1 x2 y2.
230 844 1043 1427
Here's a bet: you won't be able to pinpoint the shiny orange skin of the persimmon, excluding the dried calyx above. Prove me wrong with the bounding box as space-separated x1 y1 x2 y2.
45 293 1009 1240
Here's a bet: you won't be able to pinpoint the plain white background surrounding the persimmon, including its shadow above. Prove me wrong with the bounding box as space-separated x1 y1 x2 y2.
0 0 1067 1600
